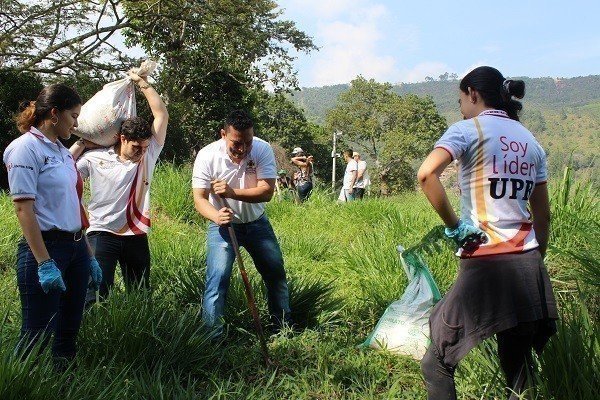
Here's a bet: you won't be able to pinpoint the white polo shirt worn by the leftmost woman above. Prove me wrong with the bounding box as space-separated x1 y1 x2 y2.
3 127 82 232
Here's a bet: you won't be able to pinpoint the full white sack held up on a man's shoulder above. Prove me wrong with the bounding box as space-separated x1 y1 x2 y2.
75 60 156 146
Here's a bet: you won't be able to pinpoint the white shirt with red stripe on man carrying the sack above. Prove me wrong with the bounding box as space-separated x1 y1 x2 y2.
77 137 163 235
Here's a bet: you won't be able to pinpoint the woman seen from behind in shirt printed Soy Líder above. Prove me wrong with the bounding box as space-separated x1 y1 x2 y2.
418 67 558 400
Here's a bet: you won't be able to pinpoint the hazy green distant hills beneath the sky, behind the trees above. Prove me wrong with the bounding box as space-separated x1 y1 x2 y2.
290 75 600 180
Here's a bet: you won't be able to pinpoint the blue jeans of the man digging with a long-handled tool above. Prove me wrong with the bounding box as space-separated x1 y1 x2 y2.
202 214 291 336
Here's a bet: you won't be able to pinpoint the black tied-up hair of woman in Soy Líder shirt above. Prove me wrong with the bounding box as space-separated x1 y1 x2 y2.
459 67 525 121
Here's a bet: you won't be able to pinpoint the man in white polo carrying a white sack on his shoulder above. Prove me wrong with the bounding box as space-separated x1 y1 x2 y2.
71 72 169 301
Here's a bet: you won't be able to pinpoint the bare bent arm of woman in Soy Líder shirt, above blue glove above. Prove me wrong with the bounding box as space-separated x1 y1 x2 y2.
417 149 458 228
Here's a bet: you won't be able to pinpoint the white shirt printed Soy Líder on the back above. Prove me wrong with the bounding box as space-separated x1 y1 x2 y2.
435 110 547 257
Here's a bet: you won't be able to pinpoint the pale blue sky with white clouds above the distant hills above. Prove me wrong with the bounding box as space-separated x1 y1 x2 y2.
278 0 600 87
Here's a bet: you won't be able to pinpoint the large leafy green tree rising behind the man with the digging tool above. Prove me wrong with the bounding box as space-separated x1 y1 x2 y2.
124 0 315 156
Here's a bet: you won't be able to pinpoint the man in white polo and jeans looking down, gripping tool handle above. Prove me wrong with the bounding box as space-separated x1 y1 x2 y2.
192 110 291 336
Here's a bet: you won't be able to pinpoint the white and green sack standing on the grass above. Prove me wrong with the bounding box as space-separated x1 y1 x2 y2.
363 246 441 360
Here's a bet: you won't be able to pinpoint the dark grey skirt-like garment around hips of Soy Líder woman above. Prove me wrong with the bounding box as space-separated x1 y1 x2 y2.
429 249 558 367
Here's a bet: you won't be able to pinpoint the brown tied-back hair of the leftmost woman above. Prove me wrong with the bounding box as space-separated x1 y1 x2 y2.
16 83 82 133
